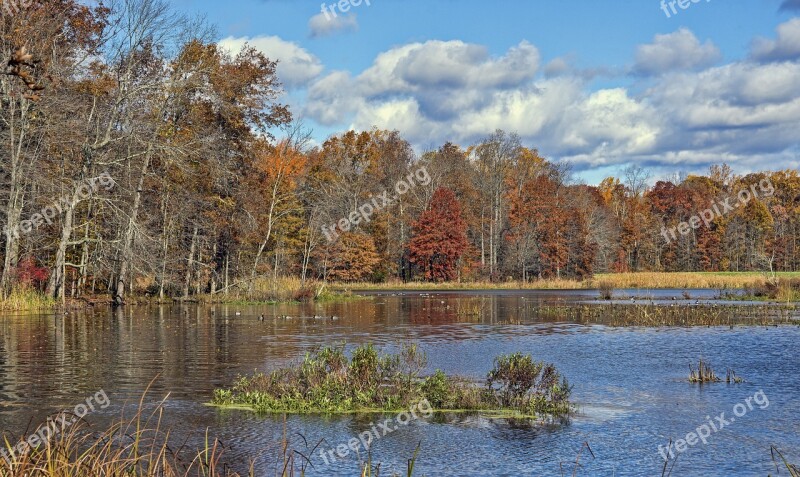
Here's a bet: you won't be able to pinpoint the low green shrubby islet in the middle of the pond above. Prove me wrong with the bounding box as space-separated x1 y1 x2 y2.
213 345 571 417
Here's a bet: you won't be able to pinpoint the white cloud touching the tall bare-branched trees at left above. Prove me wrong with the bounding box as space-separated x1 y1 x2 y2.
219 36 324 87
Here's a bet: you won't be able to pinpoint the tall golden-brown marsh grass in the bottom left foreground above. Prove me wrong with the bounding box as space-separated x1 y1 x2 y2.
0 391 420 477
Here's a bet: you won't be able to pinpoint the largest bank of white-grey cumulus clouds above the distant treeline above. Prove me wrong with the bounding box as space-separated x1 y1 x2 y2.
303 30 800 172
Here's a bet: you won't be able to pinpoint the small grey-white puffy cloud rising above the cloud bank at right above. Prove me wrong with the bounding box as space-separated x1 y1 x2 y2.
633 28 720 75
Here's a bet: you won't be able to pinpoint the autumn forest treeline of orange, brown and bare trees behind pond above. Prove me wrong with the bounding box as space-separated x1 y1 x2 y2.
0 0 800 303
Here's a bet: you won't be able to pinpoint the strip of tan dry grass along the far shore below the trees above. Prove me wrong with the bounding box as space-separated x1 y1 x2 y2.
331 272 800 290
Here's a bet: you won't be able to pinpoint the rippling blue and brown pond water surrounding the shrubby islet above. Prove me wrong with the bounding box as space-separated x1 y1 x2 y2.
0 290 800 477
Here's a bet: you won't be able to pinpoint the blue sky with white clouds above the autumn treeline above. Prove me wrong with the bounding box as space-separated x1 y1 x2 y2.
173 0 800 184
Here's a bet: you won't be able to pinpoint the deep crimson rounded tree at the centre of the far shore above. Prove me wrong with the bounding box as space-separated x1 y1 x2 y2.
408 187 468 281
